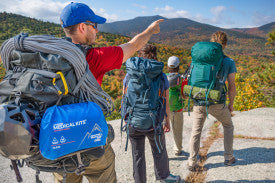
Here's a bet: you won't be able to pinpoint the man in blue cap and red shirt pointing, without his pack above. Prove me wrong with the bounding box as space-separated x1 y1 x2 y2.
54 3 163 183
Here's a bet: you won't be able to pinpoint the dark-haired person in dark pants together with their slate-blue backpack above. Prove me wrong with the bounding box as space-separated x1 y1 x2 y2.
122 44 180 183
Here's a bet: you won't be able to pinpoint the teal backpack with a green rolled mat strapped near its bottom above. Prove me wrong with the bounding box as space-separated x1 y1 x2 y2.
184 42 226 115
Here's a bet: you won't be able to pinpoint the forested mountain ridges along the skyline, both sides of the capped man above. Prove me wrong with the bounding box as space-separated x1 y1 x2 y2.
0 12 275 55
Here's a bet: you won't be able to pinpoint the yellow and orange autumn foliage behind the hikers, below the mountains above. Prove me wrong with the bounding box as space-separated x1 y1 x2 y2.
0 29 275 120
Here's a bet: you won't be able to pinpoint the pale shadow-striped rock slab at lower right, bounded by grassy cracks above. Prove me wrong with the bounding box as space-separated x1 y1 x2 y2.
205 139 275 183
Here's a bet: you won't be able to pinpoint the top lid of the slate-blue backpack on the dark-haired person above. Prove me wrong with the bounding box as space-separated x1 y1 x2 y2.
126 57 164 79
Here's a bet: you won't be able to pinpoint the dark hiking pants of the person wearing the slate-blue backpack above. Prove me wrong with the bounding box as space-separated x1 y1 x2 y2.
129 126 170 183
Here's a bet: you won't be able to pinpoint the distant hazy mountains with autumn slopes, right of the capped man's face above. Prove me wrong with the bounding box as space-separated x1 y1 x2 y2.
99 16 275 55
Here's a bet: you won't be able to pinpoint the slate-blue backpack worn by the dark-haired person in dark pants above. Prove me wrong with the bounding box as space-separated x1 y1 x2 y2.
121 57 166 152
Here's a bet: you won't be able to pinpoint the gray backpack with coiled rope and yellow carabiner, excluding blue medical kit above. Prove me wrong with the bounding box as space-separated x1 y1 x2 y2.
0 34 114 182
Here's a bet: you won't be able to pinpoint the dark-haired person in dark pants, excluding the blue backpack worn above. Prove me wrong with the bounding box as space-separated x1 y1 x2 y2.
123 44 180 183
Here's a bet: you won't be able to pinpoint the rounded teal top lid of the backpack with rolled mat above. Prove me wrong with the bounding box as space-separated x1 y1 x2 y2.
191 42 223 66
